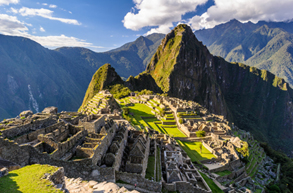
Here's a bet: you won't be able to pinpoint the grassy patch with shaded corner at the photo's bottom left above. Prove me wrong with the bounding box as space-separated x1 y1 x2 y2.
0 164 62 193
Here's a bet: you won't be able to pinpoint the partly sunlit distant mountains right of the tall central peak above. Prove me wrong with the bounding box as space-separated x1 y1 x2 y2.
195 19 293 85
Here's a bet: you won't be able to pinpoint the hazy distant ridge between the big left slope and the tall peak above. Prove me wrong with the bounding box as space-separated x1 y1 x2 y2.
56 34 165 78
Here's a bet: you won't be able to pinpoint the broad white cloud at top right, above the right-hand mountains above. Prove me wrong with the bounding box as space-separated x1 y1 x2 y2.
189 0 293 29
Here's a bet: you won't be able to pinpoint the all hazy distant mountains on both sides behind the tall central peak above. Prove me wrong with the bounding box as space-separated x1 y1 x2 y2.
0 20 293 122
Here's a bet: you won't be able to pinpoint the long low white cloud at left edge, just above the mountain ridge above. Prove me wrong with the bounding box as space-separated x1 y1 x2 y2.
0 14 103 49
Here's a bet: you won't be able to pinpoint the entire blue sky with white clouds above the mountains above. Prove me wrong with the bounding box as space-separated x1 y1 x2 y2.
0 0 293 52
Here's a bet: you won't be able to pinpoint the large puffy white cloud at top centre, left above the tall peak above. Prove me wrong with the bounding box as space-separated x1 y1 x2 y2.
122 0 207 34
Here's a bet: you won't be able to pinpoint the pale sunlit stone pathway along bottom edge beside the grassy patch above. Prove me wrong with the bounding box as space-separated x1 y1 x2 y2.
65 177 139 193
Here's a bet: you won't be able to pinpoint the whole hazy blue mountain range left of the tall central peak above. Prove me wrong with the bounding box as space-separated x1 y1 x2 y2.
0 34 164 119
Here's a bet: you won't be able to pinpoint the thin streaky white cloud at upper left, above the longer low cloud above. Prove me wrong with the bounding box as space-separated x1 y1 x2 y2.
18 7 81 25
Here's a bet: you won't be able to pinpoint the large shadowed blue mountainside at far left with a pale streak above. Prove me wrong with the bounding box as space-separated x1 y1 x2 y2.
0 35 91 119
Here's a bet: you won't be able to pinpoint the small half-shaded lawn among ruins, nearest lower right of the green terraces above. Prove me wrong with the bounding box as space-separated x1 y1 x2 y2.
176 140 215 162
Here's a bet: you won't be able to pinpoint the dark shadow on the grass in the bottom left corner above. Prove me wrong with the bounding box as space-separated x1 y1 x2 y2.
0 173 21 193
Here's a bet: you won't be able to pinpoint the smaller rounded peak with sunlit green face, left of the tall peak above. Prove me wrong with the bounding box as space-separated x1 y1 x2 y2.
81 64 124 106
